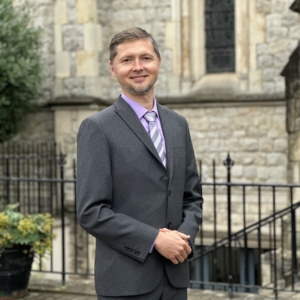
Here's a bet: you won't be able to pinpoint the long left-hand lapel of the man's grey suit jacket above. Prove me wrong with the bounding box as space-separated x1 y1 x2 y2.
114 96 164 167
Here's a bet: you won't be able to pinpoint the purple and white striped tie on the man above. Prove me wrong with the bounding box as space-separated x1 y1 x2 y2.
144 111 167 167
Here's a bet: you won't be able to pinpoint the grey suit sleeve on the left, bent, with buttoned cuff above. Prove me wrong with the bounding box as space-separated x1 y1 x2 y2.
76 118 158 262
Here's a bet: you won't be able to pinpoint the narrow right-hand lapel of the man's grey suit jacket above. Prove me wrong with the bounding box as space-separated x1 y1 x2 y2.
157 103 174 179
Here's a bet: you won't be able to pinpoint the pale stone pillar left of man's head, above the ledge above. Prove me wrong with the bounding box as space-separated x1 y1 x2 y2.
54 0 103 102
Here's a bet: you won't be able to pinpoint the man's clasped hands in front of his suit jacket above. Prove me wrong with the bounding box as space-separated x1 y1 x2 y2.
154 228 192 265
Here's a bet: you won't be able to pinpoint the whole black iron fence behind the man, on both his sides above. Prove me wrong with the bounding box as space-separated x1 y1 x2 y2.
0 146 300 297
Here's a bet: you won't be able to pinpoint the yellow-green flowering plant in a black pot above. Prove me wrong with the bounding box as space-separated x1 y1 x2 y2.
0 204 54 300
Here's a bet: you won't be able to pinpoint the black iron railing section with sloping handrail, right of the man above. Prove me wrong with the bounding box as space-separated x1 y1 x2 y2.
191 155 300 298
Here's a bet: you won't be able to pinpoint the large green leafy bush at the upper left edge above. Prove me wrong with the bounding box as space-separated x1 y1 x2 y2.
0 0 42 143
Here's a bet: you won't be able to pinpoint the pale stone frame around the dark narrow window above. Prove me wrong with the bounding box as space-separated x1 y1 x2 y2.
178 0 264 95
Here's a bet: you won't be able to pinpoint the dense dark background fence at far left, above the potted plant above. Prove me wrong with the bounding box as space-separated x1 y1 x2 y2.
0 143 60 214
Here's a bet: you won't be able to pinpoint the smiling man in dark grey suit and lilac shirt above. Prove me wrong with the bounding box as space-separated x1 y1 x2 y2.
77 28 203 300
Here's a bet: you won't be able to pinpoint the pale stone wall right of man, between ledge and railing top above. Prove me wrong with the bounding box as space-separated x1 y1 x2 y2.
175 104 288 183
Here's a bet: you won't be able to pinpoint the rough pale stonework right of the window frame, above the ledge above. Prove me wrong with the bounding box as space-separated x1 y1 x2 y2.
256 0 300 94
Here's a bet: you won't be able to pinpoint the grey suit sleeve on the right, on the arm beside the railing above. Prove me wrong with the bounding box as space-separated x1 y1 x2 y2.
177 122 203 258
